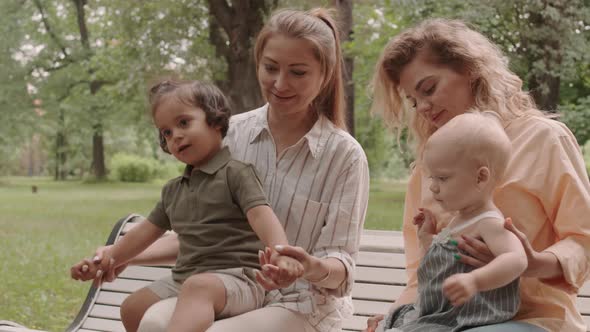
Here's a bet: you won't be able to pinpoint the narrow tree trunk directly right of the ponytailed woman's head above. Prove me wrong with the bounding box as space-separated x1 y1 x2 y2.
334 0 354 136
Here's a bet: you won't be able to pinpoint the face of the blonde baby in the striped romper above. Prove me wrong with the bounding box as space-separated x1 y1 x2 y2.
424 144 484 211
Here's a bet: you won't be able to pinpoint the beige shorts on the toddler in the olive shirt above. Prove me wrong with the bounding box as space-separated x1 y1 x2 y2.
147 267 265 319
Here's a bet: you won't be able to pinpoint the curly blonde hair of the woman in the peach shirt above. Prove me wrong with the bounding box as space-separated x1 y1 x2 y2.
371 19 543 156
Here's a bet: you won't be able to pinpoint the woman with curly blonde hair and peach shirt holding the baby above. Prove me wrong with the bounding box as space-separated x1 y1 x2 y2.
367 19 590 332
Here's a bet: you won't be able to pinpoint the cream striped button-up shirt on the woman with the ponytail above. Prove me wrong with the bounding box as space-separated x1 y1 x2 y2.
225 105 369 332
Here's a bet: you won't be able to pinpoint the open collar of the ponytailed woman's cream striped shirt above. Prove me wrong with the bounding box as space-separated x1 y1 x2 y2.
250 104 336 158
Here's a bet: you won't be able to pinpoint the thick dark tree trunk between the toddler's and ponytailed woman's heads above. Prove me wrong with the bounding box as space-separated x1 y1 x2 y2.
208 0 276 113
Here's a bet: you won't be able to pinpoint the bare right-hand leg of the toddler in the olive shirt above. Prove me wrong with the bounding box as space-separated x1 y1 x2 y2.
168 273 226 332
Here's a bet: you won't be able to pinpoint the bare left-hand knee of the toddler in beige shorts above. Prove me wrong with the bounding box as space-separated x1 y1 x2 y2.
121 287 161 332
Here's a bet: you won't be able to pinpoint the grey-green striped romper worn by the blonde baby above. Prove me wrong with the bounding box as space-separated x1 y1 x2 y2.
377 211 520 332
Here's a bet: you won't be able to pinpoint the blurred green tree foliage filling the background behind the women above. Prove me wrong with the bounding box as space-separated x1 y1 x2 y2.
0 0 590 178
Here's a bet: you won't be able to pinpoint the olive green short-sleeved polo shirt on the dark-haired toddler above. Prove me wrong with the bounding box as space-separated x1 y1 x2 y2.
148 147 268 282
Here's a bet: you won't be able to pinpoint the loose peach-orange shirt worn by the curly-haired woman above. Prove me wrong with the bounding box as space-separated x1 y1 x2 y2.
400 116 590 332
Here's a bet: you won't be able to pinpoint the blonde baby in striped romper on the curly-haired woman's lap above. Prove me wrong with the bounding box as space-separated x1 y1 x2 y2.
377 112 527 332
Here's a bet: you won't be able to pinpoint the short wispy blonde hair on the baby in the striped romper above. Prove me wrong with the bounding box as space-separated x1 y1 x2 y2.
424 110 512 185
